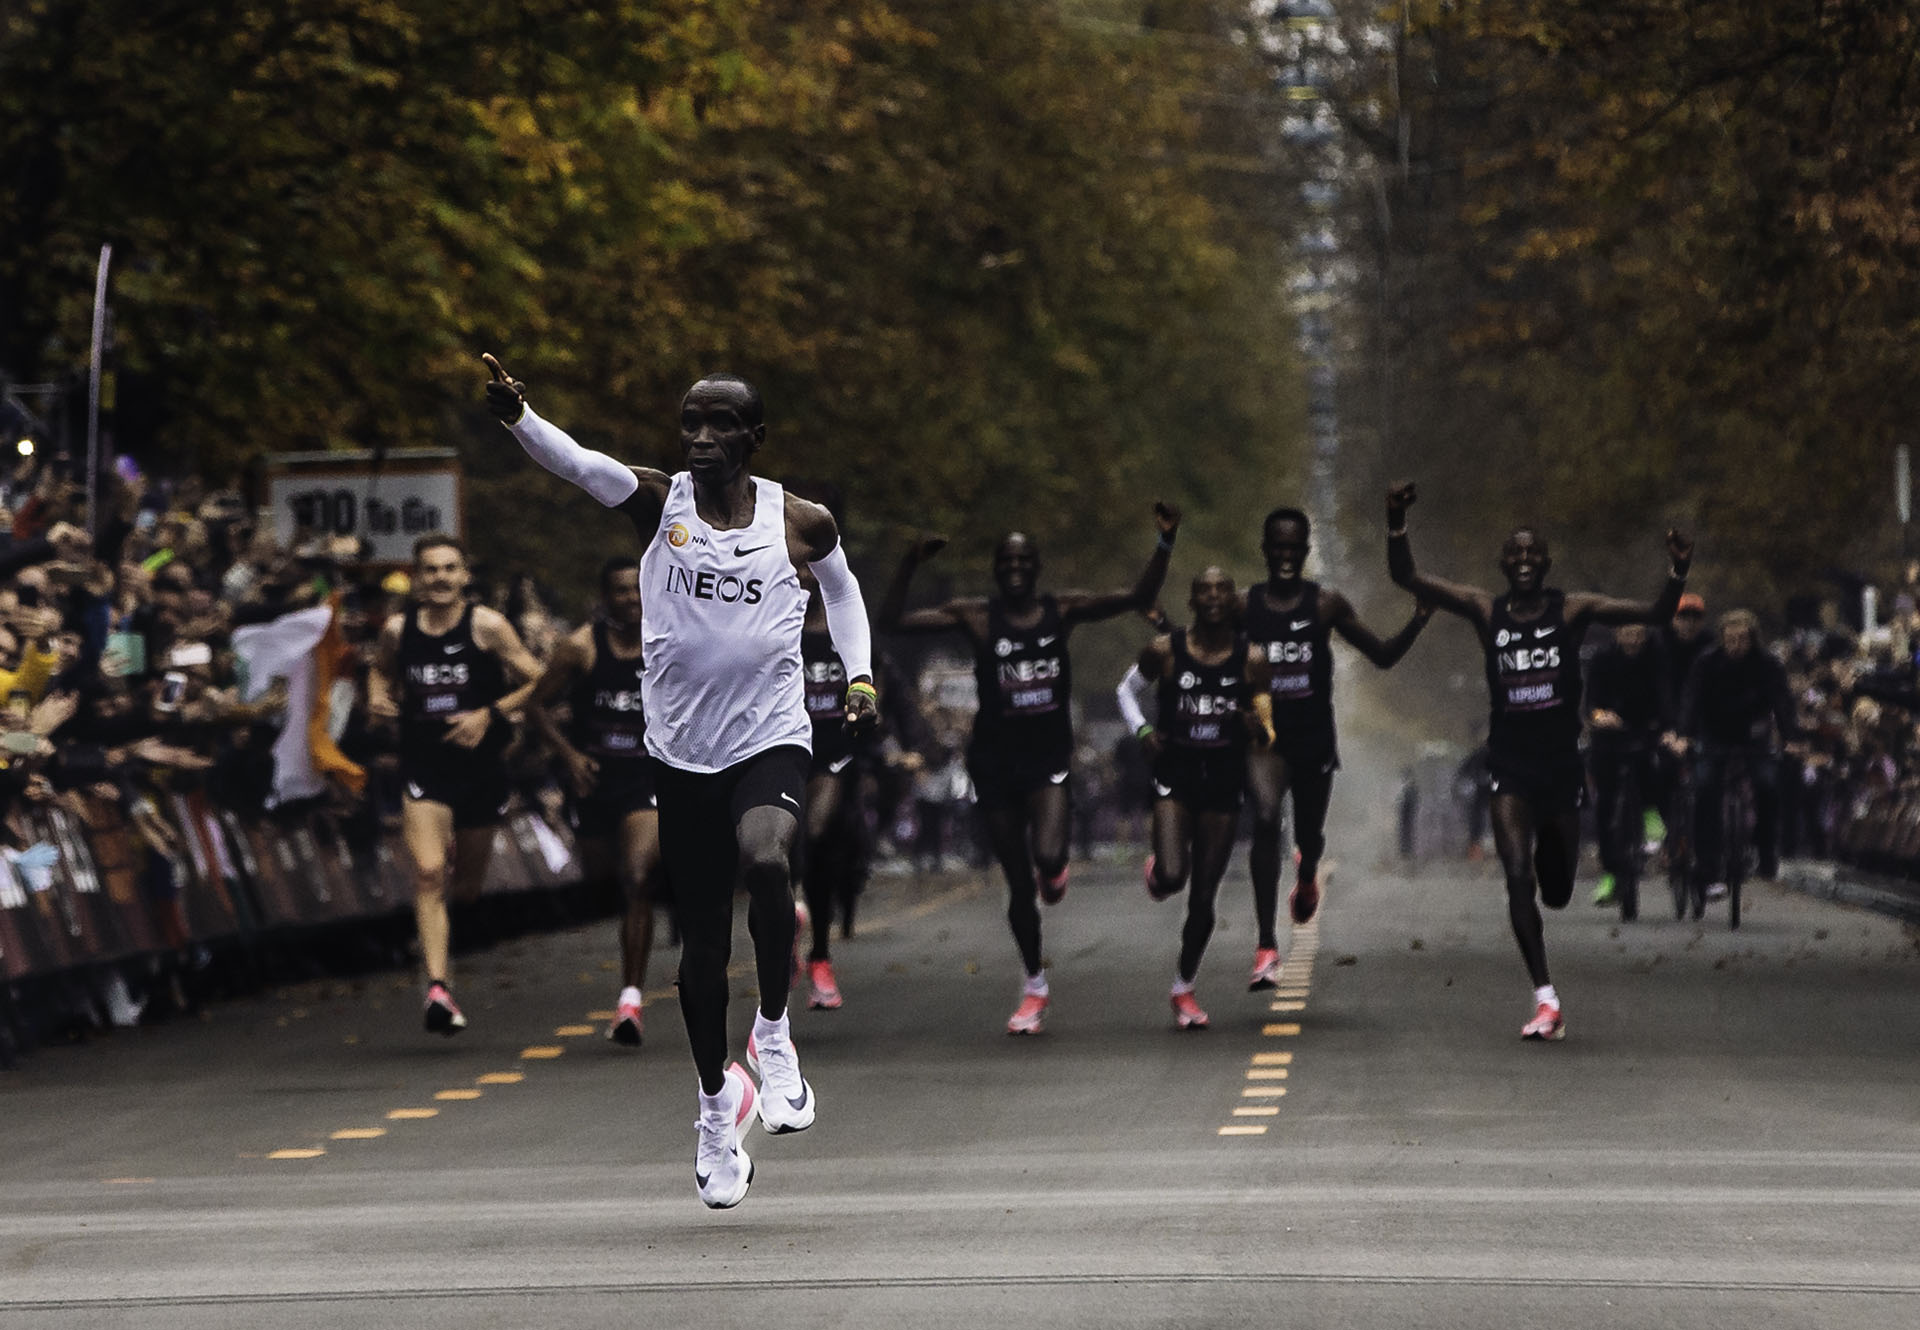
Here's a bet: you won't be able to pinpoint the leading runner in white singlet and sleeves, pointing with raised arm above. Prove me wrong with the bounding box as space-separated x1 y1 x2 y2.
486 355 879 1209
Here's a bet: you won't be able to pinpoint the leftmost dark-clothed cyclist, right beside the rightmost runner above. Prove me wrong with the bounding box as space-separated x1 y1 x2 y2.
1586 624 1674 908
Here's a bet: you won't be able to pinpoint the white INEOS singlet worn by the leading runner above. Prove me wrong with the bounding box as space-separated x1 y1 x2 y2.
639 472 812 772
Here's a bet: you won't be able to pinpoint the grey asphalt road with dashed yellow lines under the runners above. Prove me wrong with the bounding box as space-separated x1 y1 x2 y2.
0 840 1920 1330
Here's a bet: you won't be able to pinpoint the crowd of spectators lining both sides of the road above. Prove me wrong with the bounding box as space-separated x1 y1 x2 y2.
15 435 1920 1051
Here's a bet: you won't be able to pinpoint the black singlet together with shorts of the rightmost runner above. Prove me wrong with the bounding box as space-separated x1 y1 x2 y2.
1486 589 1586 806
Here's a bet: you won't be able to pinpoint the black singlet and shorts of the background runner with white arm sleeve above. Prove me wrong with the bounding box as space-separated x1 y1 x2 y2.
1154 628 1250 812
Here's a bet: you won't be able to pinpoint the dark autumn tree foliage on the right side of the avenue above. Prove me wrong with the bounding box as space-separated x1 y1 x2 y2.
1331 0 1920 605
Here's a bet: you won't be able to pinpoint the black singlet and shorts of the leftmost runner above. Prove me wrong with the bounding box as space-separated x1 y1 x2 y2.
399 605 511 827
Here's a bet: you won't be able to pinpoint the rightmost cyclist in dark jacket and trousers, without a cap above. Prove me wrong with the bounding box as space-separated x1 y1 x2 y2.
1680 610 1799 900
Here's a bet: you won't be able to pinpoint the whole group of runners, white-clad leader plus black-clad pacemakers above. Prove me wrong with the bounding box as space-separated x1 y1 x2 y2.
371 355 1692 1209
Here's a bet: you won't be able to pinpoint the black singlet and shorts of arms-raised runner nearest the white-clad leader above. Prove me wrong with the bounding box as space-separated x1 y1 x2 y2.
968 595 1073 802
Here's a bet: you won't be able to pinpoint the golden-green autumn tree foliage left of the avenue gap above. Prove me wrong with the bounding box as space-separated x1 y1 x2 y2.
0 0 1304 594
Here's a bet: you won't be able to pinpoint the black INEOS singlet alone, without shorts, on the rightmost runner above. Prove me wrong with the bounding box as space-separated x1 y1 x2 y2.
1486 591 1580 760
